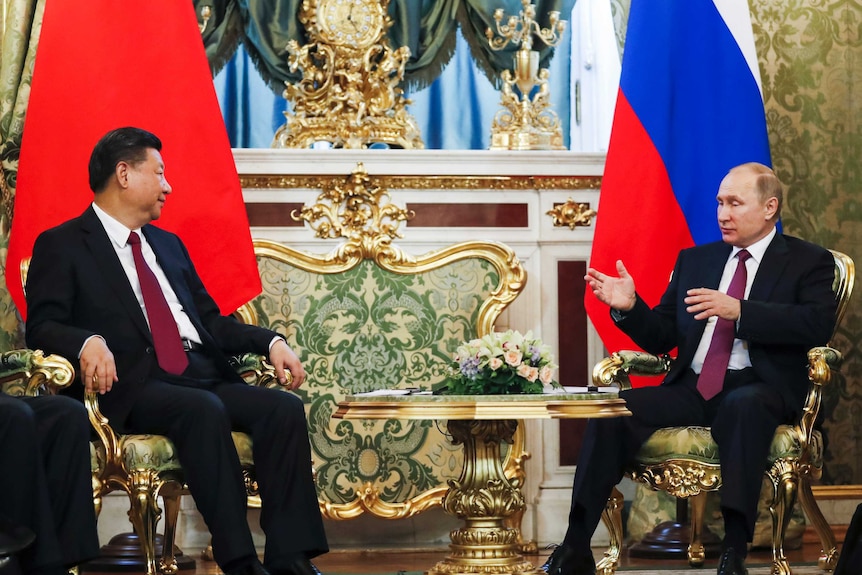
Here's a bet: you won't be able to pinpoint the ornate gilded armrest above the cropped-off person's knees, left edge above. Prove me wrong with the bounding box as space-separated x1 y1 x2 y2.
0 349 75 396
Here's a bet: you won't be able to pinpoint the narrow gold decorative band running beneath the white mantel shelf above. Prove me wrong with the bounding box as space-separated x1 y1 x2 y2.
239 174 602 190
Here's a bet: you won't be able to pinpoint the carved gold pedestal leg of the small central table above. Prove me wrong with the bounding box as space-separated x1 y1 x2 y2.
428 420 540 575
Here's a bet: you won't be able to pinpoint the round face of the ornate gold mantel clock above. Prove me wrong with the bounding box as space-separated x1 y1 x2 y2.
317 0 383 48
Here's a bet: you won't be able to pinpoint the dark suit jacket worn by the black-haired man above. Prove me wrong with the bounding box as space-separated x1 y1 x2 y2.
26 207 277 429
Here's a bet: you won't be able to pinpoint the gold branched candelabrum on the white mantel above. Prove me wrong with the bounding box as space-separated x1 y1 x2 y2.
485 0 566 150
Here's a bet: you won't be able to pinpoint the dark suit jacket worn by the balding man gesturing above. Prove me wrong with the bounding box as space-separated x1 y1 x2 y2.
617 234 836 414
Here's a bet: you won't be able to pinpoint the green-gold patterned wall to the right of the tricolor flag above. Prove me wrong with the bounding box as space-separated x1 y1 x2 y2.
750 0 862 485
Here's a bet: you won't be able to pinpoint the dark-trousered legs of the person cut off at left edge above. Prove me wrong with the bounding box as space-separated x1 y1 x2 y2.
0 394 99 575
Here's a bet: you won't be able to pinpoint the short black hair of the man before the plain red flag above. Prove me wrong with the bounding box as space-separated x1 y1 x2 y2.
88 127 162 194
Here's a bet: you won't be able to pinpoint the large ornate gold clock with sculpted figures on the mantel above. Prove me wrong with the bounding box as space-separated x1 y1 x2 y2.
272 0 425 149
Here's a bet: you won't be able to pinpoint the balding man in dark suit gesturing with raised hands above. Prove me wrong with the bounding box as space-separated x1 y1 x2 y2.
544 163 836 575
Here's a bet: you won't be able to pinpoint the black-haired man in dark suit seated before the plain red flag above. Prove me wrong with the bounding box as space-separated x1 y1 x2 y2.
27 128 328 575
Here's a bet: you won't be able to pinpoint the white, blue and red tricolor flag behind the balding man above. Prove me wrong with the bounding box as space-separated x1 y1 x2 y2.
584 0 771 362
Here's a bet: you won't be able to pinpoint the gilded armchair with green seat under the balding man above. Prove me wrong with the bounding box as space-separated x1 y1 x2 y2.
593 251 855 575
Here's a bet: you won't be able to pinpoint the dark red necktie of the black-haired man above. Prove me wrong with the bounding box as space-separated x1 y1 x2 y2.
128 232 189 374
